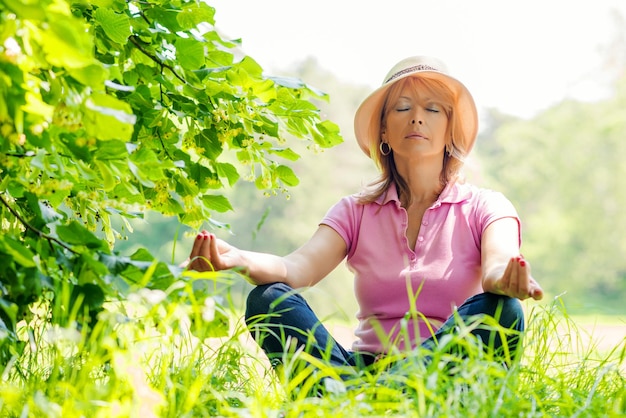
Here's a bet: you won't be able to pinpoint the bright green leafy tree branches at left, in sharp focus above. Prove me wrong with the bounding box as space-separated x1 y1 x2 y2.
0 0 341 356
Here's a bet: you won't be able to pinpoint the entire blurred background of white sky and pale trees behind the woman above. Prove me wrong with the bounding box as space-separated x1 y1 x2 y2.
116 0 626 321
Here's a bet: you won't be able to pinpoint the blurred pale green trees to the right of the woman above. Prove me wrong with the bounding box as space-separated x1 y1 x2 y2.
481 79 626 313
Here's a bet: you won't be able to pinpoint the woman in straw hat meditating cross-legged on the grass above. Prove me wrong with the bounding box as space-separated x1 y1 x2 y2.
189 56 543 376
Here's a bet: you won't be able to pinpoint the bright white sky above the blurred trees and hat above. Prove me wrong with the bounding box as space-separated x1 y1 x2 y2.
207 0 626 117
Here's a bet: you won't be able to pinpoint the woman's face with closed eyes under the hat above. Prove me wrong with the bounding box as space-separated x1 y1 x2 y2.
382 83 448 161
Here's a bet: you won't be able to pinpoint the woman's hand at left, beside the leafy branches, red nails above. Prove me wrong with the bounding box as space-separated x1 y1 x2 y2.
186 231 243 271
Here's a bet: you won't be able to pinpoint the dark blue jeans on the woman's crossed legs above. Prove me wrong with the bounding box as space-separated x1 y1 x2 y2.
245 283 524 369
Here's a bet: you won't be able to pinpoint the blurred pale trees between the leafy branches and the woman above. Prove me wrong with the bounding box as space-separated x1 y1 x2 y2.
116 58 377 319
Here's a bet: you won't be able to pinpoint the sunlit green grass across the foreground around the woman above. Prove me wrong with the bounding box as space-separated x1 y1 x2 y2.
0 289 626 418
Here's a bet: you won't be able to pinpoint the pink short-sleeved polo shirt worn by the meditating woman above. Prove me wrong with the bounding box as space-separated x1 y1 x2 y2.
321 183 521 353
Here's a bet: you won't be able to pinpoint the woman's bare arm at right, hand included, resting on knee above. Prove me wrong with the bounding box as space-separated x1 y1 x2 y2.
481 218 543 300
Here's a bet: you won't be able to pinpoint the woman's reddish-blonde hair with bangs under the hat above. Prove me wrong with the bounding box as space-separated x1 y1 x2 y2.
358 77 473 204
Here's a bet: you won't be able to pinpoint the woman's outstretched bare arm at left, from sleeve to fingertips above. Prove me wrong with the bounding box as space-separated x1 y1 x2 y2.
183 225 347 288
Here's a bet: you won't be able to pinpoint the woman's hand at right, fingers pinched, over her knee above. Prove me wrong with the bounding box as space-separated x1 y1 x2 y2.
494 256 543 300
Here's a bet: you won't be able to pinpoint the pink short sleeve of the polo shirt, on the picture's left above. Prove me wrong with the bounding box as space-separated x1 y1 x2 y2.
320 196 363 257
